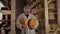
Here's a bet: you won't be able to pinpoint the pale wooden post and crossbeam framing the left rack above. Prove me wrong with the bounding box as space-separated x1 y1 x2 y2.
0 0 16 34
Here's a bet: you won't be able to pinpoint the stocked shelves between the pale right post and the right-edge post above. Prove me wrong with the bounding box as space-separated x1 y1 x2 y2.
48 0 59 34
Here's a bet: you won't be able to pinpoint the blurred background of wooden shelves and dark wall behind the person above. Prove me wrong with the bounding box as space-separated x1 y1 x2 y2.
0 0 60 34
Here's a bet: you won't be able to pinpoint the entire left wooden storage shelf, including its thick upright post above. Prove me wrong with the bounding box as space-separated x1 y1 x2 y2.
0 0 16 34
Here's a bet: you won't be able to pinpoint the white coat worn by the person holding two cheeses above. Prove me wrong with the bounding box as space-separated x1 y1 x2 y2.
16 13 38 34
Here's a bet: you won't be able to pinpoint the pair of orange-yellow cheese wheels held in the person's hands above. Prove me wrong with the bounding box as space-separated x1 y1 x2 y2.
19 18 36 29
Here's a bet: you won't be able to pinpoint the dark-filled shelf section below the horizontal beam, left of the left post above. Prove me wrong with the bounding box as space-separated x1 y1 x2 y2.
0 10 11 34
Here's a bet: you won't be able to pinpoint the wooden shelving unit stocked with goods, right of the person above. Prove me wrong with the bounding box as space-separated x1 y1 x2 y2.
28 0 60 34
